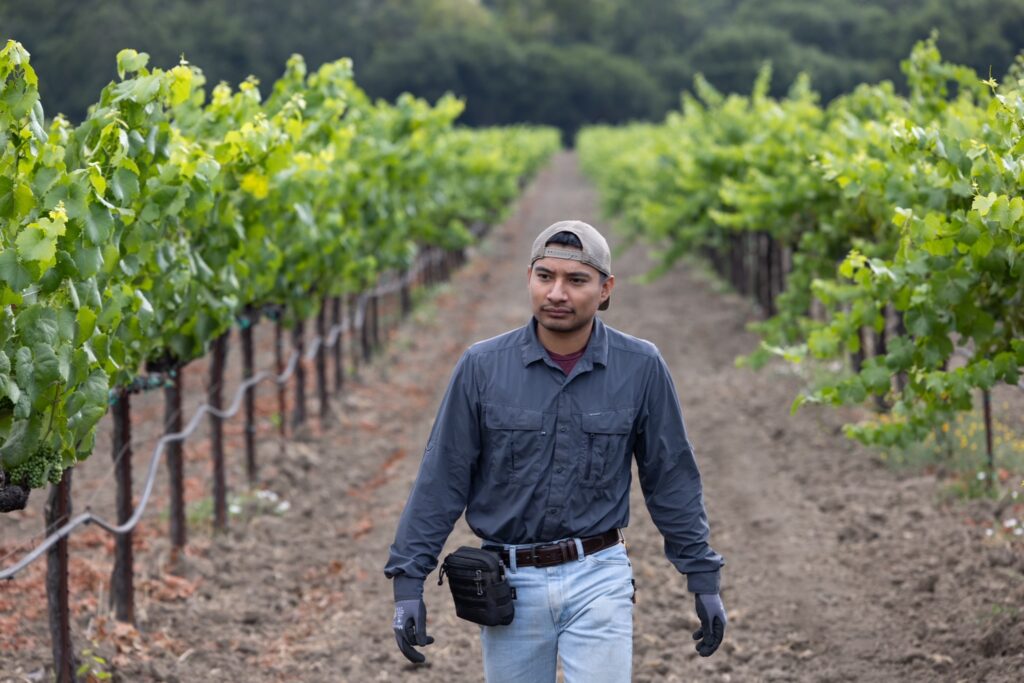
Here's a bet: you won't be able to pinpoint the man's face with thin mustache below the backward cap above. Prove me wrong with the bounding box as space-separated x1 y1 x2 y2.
527 250 615 334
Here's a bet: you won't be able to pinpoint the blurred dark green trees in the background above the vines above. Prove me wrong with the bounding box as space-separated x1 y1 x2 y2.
0 0 1024 139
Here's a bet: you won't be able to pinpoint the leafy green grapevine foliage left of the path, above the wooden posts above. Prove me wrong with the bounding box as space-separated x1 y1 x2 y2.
0 41 559 499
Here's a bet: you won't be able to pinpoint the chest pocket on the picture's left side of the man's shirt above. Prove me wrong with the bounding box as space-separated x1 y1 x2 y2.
483 404 544 483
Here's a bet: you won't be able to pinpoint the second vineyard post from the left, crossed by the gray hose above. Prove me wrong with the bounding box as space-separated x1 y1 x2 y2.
111 388 135 624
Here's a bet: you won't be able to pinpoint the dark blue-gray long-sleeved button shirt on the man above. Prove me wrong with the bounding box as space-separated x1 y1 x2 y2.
384 318 724 599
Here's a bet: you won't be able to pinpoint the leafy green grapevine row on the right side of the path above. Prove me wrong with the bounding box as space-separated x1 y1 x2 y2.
578 37 1024 445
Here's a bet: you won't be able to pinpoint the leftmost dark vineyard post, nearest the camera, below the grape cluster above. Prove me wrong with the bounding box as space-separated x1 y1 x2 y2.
45 468 77 683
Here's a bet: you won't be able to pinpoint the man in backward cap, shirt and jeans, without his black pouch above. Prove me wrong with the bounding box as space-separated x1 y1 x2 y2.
385 220 726 683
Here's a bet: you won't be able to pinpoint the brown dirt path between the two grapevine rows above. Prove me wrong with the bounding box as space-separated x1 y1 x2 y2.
0 155 1024 683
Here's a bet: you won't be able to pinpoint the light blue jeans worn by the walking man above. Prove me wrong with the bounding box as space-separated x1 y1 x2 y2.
480 543 633 683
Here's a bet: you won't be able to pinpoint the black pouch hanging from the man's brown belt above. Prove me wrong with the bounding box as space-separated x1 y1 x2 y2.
437 546 515 626
